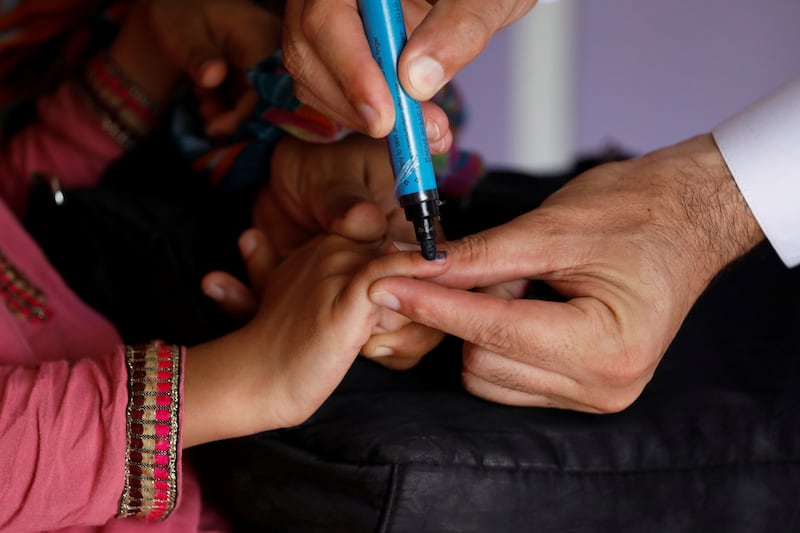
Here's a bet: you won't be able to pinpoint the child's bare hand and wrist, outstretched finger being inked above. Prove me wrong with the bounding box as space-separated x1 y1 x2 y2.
182 235 445 446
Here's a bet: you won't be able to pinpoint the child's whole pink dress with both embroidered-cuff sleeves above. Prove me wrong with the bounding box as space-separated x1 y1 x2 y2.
0 75 228 533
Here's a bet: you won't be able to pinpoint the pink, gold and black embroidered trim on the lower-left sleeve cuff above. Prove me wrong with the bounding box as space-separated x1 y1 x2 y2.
119 342 181 522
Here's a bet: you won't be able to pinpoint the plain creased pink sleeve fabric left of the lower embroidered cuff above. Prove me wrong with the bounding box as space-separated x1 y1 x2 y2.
0 351 141 531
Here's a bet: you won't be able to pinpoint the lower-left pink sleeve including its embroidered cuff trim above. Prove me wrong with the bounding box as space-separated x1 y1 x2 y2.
0 342 182 531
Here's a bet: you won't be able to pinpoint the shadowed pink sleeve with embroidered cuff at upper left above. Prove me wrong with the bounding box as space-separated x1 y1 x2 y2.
0 53 158 216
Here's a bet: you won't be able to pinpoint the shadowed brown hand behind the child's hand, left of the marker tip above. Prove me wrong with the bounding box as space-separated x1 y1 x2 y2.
202 136 400 318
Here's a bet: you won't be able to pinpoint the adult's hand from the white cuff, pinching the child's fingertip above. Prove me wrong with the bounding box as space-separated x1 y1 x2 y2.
362 135 764 412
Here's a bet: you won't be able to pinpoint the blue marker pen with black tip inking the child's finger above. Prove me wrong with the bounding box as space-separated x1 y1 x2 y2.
358 0 440 260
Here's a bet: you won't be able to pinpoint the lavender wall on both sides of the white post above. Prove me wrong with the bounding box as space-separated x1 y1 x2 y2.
458 0 800 166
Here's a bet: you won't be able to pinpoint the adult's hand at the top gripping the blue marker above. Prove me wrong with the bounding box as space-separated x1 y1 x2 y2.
283 0 536 137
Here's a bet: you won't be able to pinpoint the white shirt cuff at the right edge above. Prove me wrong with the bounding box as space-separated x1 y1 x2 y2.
712 77 800 267
